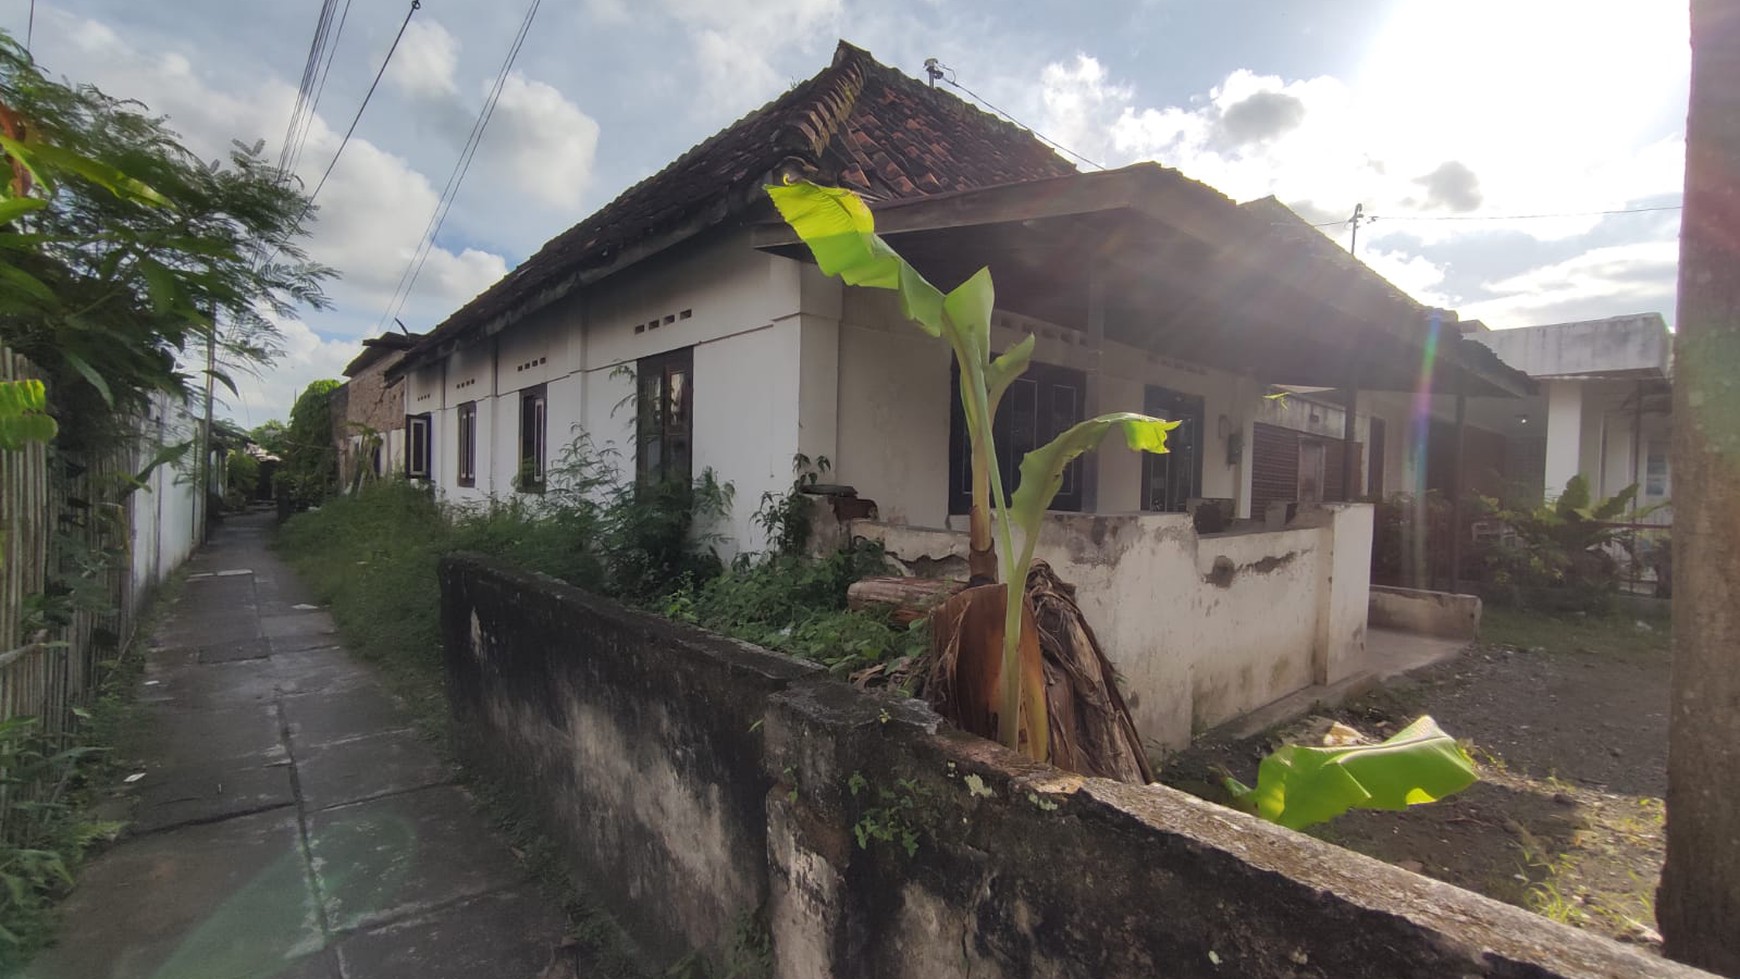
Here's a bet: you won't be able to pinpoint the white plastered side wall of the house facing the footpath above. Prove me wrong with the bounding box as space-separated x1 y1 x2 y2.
405 231 824 558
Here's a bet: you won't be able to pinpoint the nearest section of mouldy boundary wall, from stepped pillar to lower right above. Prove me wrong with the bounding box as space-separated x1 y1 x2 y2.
766 685 1700 979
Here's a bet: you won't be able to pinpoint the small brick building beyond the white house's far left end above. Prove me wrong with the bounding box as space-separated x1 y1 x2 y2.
332 332 428 492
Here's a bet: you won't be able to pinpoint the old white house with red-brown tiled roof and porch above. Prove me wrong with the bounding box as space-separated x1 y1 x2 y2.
377 36 1528 744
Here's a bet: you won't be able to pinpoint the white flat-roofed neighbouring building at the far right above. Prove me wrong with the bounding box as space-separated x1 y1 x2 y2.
1469 313 1674 522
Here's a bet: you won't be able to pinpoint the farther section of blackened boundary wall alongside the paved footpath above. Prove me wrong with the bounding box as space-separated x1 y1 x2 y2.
440 558 816 965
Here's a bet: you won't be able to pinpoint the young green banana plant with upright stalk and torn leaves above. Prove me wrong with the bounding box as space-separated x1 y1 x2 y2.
767 181 1180 758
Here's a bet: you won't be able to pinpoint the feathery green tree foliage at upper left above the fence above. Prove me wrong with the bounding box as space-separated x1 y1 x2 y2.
0 31 331 449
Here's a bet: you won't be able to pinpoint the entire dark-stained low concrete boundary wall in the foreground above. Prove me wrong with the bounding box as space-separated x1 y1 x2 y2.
442 556 1705 979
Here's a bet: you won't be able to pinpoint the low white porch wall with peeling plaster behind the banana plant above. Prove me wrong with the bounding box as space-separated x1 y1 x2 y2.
851 504 1371 749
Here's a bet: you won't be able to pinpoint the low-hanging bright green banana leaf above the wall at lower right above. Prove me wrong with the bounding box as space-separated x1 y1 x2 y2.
1227 716 1479 829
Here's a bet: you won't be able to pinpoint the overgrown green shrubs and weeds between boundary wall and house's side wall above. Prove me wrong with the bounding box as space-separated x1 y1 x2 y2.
278 436 904 688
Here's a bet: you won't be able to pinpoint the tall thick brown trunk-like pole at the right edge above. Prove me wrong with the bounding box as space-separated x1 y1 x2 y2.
1656 0 1740 976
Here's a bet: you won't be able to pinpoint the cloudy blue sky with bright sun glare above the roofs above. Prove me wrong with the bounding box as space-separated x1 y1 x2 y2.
0 0 1690 426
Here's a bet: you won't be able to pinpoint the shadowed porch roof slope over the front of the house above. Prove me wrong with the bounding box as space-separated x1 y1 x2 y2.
755 163 1533 396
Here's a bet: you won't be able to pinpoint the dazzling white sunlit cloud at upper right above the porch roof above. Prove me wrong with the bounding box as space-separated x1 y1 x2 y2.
1039 0 1686 325
